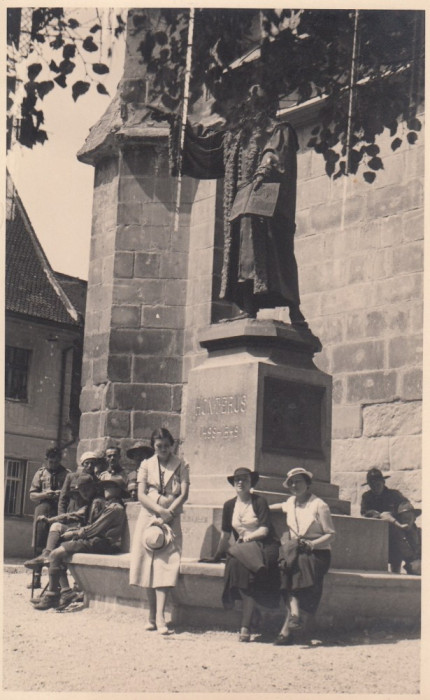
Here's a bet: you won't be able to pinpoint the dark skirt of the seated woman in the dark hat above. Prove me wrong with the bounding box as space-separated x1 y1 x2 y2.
222 541 280 610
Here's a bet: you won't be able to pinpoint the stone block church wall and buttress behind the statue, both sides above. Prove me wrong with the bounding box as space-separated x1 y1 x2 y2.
79 8 424 513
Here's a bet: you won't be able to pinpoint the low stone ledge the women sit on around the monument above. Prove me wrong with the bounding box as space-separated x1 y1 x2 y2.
70 553 421 630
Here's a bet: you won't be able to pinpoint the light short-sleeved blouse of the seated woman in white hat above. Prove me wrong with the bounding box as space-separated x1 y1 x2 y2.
282 494 335 549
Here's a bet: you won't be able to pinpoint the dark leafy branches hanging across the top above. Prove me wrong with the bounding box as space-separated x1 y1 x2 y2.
6 8 424 183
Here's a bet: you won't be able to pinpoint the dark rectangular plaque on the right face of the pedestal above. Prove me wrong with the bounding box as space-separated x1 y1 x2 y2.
263 377 325 457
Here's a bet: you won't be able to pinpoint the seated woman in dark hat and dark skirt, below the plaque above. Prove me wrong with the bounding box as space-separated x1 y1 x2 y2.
214 468 279 642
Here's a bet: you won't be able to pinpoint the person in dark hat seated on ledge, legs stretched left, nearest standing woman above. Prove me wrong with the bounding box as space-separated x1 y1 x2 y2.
34 475 128 610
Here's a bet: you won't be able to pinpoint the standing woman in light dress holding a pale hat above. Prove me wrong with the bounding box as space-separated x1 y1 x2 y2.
130 428 190 634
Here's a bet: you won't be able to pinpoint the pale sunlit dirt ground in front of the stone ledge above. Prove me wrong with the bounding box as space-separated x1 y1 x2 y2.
3 566 420 698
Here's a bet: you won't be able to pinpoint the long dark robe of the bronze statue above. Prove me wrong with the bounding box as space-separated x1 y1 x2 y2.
182 119 300 308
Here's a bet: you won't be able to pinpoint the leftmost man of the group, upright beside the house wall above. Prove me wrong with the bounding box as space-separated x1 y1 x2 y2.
29 447 69 588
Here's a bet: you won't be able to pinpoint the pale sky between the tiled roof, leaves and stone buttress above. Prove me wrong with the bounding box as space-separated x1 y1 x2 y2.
7 9 124 279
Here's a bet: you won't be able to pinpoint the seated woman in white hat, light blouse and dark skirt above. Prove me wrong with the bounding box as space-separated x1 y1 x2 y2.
269 467 335 645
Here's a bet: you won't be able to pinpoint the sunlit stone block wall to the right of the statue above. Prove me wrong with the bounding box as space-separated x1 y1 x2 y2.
288 120 424 513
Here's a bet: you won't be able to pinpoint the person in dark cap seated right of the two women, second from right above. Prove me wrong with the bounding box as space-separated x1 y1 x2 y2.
360 467 407 574
